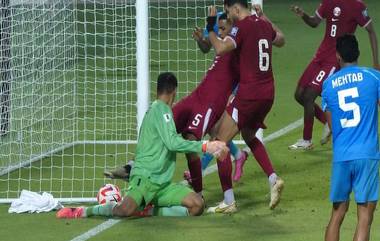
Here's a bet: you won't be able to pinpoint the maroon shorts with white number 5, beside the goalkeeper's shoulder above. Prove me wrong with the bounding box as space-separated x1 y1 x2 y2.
173 95 226 140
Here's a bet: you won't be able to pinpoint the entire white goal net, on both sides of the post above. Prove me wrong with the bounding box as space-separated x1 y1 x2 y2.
0 0 249 202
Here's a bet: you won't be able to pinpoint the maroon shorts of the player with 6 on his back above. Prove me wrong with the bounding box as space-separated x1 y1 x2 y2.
227 96 273 130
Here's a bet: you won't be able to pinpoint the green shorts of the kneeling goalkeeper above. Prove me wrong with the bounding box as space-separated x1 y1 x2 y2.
126 176 193 207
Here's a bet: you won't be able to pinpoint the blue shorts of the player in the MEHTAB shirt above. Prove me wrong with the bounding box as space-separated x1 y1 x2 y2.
330 159 379 203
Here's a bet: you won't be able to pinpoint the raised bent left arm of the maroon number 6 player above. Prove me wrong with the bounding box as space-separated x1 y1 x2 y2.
207 6 235 55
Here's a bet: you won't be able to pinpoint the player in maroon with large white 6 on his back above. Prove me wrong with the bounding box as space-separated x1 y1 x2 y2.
207 0 285 213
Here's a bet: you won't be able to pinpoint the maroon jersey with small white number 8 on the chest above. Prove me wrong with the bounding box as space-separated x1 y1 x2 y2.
314 0 371 62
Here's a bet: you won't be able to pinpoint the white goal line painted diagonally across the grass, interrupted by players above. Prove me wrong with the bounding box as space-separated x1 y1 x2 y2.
71 119 303 241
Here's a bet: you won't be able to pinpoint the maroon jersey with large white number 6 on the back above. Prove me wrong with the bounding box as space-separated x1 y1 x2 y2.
226 15 276 100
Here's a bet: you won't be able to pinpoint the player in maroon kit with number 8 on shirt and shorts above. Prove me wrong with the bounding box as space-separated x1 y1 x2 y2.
289 0 380 150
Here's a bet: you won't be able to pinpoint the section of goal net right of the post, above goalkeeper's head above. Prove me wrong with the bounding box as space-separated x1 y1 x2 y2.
149 0 223 98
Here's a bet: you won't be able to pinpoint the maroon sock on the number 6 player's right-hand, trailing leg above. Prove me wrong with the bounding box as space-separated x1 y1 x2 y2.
247 137 274 177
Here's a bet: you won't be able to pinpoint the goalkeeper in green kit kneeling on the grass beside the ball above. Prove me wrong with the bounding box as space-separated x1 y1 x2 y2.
57 73 228 218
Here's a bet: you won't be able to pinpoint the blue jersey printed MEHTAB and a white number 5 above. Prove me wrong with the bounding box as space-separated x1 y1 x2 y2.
322 66 380 162
